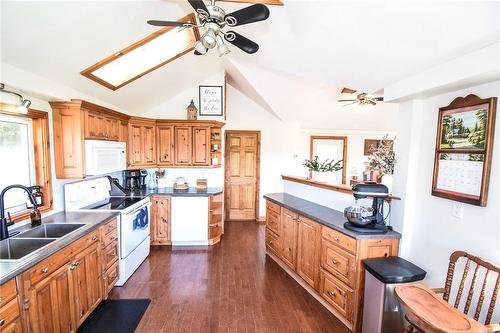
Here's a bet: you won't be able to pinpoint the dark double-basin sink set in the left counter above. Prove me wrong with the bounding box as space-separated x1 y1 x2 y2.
0 223 85 262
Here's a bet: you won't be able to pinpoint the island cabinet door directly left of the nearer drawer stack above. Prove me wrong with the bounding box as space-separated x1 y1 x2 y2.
297 216 321 289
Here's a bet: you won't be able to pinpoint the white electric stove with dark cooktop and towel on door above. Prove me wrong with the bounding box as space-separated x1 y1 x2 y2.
64 177 151 286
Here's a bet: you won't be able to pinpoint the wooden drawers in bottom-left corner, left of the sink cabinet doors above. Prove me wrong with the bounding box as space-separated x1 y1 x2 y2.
0 279 23 333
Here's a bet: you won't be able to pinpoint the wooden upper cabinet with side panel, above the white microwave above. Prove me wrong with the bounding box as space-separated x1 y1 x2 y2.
50 100 130 178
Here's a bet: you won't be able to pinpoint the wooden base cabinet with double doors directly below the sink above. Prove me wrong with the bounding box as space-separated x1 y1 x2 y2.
18 219 118 333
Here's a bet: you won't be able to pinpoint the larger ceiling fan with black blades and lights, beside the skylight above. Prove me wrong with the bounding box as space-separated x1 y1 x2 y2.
148 0 269 56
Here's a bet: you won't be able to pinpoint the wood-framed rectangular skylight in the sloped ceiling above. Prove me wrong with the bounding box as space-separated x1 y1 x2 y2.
81 14 199 90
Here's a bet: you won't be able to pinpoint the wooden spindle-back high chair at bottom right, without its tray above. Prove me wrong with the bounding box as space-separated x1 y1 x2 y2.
406 251 500 333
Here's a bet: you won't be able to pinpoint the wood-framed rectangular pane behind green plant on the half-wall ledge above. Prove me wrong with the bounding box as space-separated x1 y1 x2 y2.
309 136 347 184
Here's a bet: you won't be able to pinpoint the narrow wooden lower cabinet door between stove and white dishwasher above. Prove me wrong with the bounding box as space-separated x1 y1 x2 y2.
151 196 172 245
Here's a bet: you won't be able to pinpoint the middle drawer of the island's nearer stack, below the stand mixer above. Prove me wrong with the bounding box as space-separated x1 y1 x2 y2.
321 239 356 287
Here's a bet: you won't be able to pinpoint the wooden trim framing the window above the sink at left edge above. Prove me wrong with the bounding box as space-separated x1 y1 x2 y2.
0 104 53 222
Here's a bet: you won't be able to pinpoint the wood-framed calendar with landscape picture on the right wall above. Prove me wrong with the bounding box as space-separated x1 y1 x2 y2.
432 95 497 207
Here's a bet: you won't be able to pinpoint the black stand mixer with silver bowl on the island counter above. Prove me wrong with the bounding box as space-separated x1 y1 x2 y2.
344 184 389 234
